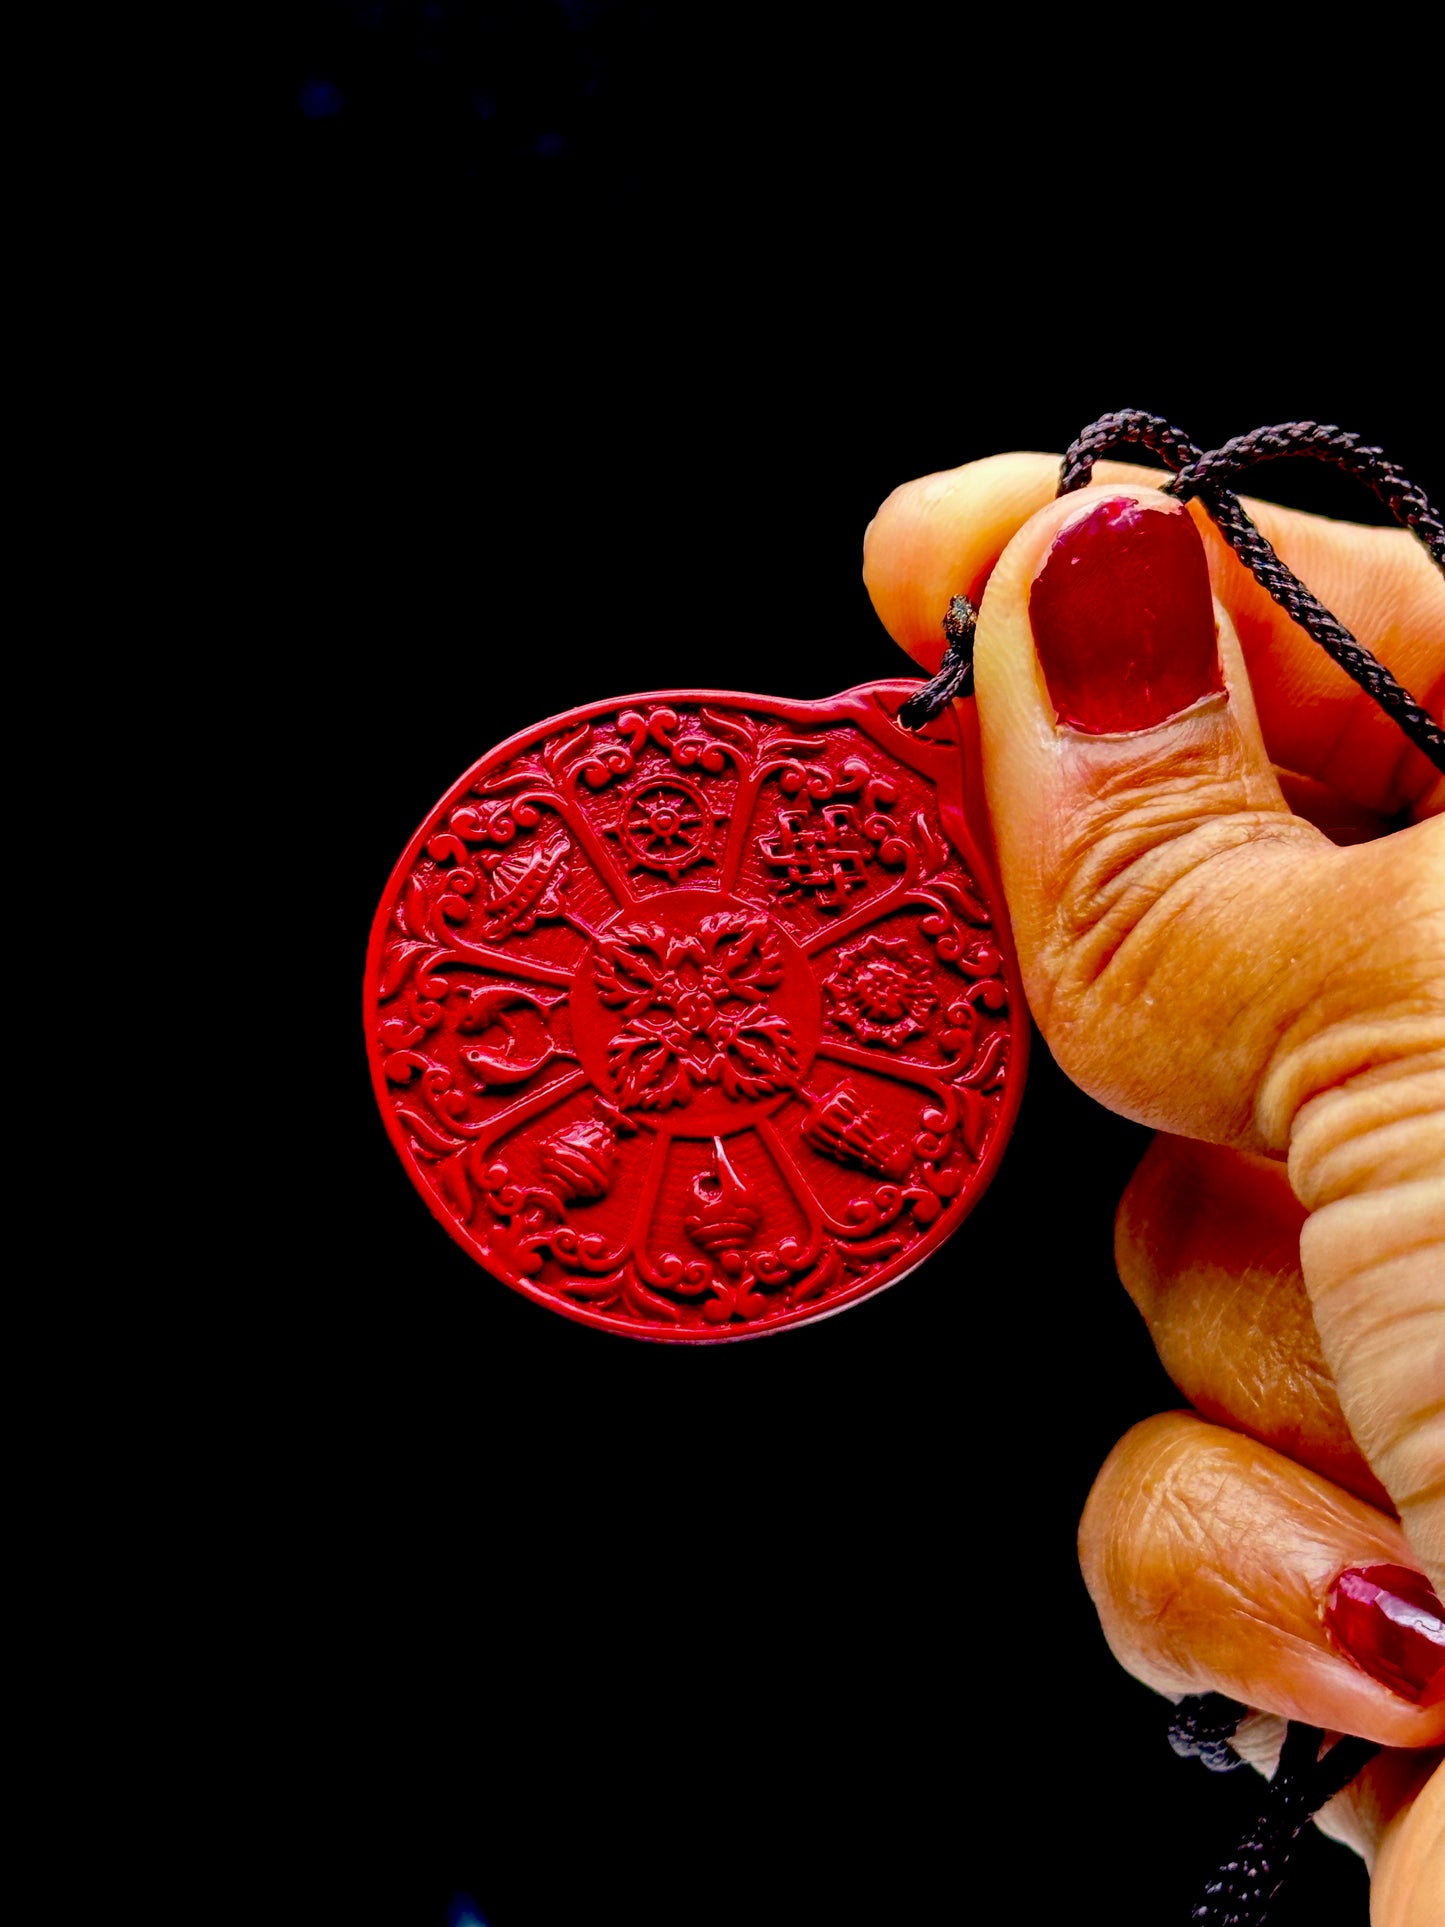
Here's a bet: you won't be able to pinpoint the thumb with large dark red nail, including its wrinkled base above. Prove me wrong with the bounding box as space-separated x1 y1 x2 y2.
975 488 1445 1580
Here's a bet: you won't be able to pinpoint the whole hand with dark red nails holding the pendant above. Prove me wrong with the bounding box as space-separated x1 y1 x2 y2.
865 455 1445 1927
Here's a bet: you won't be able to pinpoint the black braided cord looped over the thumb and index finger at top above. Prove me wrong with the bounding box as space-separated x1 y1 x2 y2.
898 409 1445 771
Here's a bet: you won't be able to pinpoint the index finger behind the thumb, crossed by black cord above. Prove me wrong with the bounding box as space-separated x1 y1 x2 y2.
863 453 1445 819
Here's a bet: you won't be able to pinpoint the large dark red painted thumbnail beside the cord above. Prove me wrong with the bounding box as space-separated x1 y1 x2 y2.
1029 495 1223 736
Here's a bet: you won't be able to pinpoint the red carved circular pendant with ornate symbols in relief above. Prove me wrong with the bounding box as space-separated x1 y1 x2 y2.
366 682 1027 1341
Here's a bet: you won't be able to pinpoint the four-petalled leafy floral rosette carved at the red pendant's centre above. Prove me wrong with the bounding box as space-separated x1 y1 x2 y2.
593 910 816 1110
